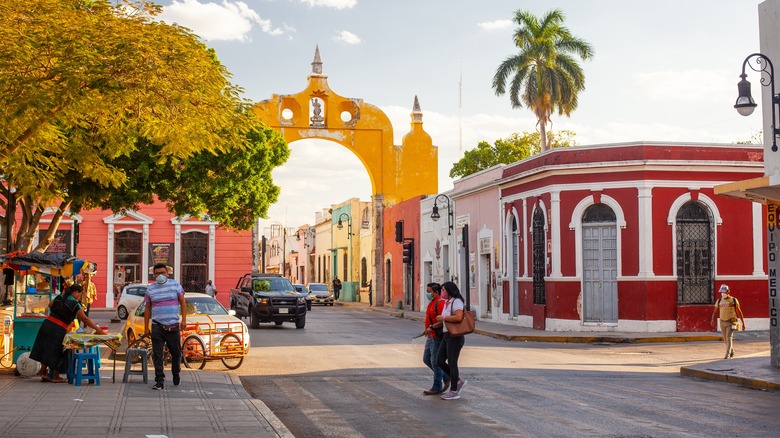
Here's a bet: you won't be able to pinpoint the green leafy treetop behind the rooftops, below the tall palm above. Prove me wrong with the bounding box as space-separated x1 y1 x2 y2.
450 130 577 178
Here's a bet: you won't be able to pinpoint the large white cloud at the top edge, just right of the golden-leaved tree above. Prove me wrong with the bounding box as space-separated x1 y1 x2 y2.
160 0 284 41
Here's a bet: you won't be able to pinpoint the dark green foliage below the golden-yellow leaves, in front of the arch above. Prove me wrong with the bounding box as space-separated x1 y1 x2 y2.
70 116 290 230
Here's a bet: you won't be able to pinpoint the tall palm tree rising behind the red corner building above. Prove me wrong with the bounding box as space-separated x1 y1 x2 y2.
493 9 593 152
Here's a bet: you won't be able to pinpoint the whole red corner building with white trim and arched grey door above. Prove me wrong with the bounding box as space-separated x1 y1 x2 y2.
494 143 768 332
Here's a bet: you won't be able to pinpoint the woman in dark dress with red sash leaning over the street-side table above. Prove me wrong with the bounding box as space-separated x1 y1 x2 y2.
30 284 105 383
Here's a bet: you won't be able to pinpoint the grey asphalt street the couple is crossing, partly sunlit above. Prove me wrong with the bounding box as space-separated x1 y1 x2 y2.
236 307 780 437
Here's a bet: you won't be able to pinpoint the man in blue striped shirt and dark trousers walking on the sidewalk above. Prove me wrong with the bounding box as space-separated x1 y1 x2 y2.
144 263 187 390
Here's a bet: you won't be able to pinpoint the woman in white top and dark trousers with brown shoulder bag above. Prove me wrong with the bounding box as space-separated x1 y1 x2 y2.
436 281 467 400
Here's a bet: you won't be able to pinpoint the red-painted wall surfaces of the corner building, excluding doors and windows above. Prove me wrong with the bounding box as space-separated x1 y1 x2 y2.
501 144 768 331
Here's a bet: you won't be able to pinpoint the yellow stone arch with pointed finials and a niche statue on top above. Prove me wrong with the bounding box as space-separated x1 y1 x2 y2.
254 47 439 208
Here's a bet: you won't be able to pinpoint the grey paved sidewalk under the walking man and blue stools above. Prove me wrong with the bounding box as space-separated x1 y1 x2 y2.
0 366 292 438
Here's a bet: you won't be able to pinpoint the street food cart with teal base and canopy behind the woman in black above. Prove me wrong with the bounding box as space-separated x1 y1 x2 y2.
0 252 94 363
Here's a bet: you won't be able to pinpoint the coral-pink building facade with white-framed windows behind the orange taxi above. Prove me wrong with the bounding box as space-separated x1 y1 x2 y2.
39 198 252 308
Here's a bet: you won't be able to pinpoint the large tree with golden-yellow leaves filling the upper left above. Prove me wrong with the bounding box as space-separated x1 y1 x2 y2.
0 0 288 250
